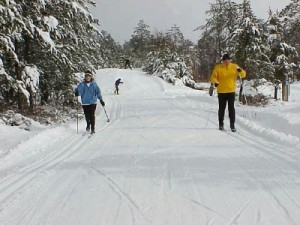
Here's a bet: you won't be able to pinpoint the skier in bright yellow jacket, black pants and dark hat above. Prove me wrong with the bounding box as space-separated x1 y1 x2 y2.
211 54 246 132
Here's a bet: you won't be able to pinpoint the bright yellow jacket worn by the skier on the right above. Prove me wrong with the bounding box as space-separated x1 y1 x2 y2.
210 63 246 93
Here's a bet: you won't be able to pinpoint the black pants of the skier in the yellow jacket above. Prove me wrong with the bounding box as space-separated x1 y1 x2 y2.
218 92 235 128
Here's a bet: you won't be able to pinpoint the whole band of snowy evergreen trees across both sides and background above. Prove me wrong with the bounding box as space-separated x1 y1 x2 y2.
0 0 300 119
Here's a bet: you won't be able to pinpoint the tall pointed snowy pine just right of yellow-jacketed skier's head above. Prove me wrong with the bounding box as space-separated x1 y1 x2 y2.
225 0 274 79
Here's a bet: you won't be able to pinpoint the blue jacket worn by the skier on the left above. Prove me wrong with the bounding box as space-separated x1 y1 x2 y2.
75 81 102 105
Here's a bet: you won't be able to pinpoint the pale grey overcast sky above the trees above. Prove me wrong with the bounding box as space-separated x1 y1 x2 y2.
91 0 291 44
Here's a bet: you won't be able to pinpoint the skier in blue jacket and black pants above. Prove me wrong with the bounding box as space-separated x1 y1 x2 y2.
75 71 105 134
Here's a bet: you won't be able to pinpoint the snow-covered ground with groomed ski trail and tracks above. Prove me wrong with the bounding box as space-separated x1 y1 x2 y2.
0 69 300 225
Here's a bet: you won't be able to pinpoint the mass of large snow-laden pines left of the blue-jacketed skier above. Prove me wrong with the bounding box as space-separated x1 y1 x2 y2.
0 0 101 112
